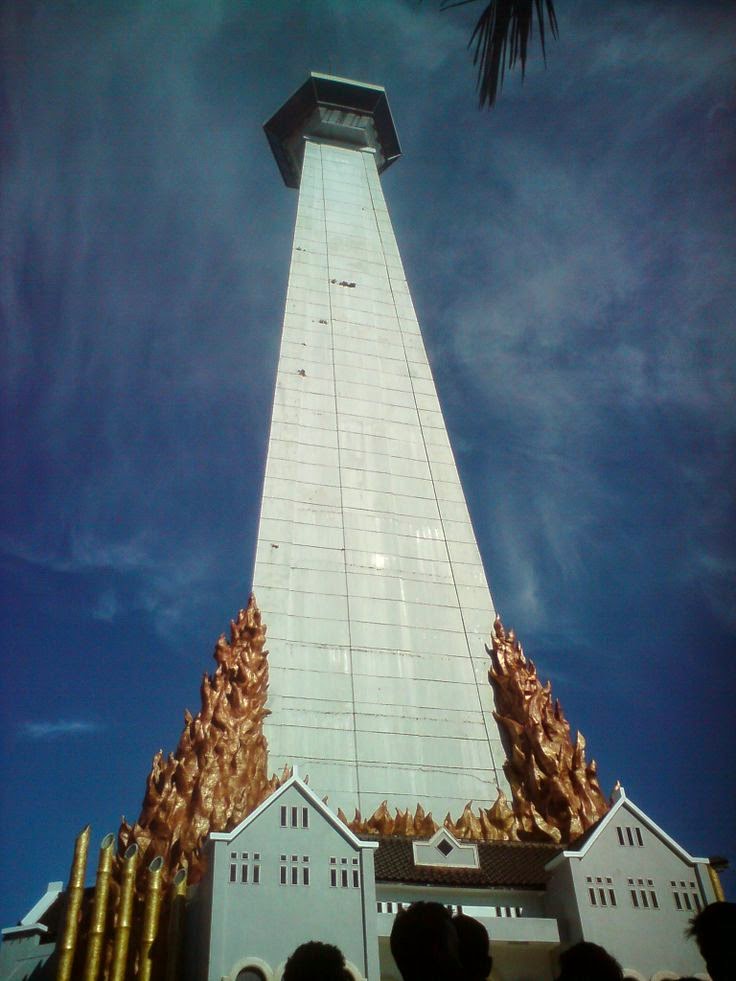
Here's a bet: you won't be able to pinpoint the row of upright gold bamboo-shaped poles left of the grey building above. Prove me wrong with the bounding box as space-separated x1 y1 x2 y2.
55 825 187 981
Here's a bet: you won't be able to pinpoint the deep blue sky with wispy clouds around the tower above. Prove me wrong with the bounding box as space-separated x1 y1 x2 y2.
0 0 736 925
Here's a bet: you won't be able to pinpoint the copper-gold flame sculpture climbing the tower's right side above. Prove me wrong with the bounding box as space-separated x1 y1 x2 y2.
489 618 610 843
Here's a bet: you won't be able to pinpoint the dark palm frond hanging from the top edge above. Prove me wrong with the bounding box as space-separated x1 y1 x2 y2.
441 0 559 109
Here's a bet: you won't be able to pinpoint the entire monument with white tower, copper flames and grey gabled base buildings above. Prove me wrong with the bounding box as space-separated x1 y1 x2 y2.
0 73 723 981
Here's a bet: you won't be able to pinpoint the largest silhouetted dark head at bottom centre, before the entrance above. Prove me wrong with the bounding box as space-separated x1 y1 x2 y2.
391 903 463 981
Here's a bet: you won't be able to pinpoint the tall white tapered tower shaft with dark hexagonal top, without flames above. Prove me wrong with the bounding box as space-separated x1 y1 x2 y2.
253 73 507 820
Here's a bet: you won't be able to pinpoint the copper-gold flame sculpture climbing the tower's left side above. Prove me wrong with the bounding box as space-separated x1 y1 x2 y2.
118 596 289 884
